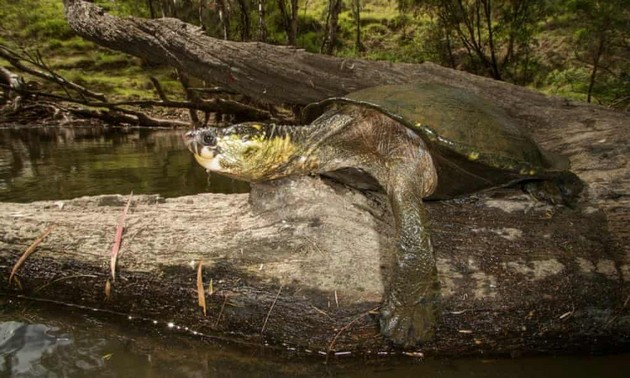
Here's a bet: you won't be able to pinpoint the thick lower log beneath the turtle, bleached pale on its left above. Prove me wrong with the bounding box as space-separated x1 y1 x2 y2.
0 178 630 356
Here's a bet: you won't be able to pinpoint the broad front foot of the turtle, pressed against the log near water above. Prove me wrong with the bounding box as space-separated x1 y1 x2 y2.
380 290 438 347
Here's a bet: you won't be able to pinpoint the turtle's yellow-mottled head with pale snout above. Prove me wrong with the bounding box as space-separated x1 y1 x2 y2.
184 122 296 181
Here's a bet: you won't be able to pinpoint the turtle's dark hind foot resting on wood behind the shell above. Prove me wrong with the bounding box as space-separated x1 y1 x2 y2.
522 171 584 208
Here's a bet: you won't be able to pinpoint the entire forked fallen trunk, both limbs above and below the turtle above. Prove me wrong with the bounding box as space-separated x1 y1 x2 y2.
7 2 630 356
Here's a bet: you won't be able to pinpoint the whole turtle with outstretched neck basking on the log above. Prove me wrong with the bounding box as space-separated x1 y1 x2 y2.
184 83 582 347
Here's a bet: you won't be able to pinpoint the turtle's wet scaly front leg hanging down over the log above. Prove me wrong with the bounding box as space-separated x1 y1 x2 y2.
380 172 440 347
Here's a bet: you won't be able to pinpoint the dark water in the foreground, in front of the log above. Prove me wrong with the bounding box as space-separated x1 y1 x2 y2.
0 297 630 378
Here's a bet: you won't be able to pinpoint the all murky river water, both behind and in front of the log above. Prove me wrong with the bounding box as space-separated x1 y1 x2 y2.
0 127 630 378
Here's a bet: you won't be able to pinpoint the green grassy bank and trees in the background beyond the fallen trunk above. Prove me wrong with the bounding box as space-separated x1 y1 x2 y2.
0 0 630 110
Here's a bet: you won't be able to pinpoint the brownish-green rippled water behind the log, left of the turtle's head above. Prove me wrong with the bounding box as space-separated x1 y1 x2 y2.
0 127 249 202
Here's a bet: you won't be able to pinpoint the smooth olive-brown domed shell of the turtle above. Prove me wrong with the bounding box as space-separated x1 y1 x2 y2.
303 83 568 197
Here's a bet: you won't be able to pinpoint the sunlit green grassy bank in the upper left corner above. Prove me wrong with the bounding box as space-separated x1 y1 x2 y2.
0 0 182 100
